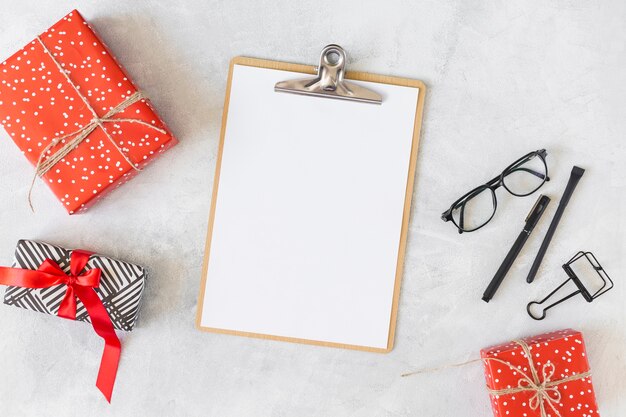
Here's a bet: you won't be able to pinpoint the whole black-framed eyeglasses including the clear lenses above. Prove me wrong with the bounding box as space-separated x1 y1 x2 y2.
441 149 550 233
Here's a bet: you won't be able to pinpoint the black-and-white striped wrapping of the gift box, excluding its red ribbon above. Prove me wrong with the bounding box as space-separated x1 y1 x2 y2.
4 240 146 331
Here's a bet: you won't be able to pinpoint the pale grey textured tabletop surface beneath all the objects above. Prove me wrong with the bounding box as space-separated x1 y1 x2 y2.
0 0 626 417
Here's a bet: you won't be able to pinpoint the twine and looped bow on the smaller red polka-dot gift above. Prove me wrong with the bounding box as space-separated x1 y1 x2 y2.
483 340 591 417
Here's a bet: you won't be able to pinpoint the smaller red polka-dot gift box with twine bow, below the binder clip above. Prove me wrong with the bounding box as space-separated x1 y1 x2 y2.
480 329 599 417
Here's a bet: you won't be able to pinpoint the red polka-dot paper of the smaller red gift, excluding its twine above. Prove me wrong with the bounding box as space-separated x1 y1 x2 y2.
480 329 599 417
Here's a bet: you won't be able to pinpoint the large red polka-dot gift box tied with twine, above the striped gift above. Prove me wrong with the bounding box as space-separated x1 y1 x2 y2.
0 10 177 214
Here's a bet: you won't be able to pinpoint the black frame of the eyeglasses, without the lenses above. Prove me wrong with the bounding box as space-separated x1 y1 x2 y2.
441 149 550 234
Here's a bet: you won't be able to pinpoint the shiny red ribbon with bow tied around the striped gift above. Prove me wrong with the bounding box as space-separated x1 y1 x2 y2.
0 250 122 402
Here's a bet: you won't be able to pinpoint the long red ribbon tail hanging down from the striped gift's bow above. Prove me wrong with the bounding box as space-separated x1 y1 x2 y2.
74 286 122 403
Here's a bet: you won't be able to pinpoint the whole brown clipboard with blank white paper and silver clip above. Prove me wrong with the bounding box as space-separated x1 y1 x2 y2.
196 45 426 352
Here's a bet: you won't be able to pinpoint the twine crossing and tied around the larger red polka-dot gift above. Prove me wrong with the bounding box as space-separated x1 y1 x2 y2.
28 37 167 210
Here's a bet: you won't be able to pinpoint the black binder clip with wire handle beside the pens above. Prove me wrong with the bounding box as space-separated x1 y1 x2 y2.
526 251 613 320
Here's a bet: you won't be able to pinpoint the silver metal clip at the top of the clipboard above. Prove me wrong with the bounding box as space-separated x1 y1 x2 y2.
274 44 383 104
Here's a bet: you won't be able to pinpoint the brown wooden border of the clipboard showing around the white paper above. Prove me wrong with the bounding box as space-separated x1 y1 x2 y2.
196 56 426 353
